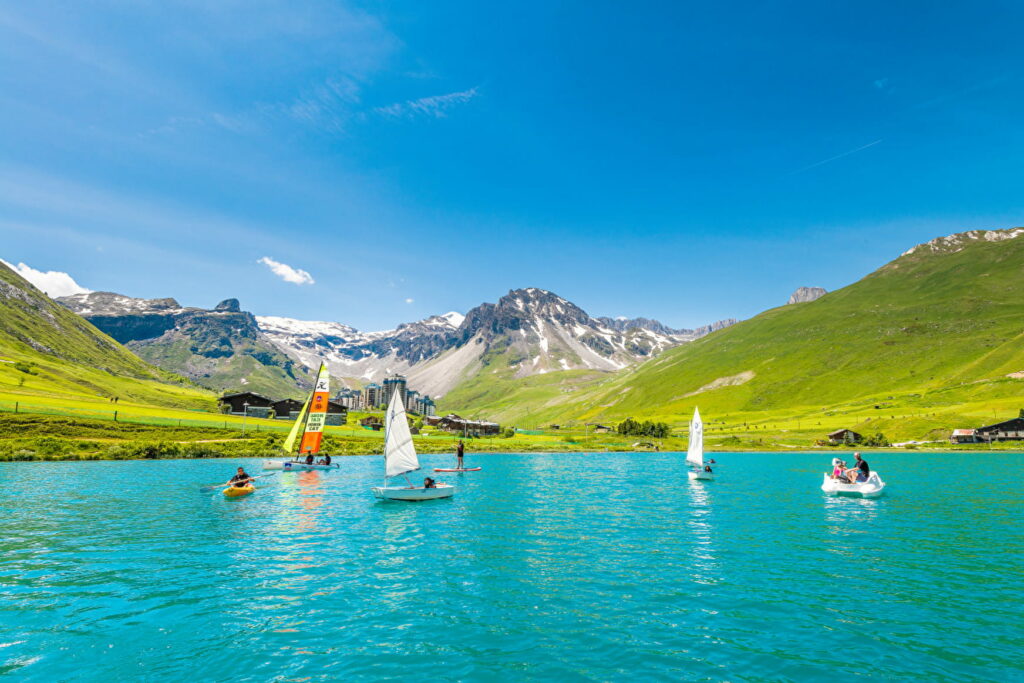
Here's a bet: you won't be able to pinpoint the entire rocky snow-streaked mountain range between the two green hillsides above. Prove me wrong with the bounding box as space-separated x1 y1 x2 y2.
57 288 736 396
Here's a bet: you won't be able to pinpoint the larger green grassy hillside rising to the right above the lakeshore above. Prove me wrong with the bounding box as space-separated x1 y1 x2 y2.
443 230 1024 436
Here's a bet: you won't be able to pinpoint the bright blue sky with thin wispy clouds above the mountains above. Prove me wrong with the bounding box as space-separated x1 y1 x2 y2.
0 0 1024 329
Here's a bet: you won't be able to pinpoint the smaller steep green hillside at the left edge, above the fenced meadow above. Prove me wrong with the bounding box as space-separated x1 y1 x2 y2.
0 263 215 410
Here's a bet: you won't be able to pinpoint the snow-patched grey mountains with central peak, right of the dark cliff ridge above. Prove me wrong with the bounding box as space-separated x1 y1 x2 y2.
256 288 733 396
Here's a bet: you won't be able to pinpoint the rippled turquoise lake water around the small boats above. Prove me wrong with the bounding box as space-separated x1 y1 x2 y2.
0 454 1024 681
